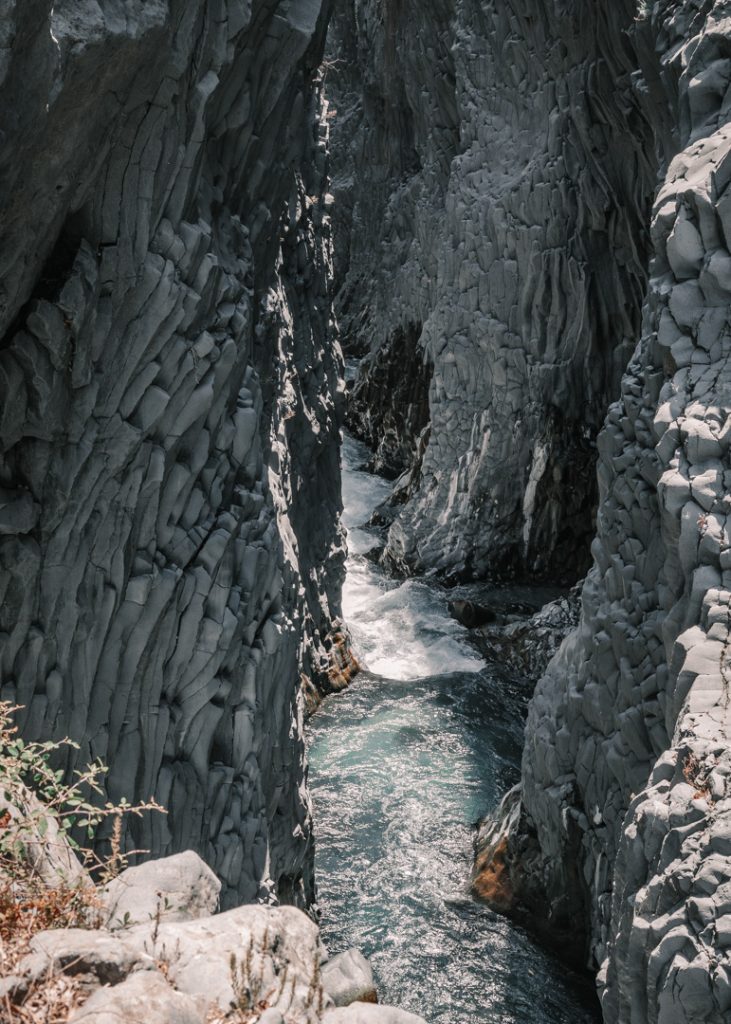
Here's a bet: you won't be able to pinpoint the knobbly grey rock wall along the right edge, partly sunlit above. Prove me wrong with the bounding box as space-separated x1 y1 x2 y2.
489 0 731 1024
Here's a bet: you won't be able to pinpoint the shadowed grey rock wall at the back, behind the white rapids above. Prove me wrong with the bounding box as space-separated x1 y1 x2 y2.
327 0 656 581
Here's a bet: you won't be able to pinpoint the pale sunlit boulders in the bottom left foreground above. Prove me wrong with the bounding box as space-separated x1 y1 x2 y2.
0 852 424 1024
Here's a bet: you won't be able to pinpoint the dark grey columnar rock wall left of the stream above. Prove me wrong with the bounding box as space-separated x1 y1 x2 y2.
0 0 343 905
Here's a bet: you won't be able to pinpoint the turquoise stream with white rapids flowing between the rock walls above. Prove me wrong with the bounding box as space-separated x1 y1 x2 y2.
309 436 599 1024
